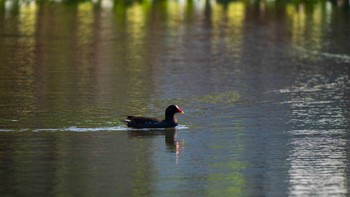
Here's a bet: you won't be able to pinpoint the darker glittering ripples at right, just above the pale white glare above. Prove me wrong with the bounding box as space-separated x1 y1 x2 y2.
280 72 350 129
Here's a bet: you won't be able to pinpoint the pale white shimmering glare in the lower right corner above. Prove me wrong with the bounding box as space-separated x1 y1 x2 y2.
288 130 348 196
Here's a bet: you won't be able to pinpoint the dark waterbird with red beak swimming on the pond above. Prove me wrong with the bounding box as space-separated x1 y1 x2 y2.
125 105 184 129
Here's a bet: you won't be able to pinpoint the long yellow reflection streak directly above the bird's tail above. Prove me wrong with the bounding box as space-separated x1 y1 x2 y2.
123 2 153 113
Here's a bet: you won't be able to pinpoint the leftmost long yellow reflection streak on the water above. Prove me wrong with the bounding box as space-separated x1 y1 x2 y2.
10 2 37 116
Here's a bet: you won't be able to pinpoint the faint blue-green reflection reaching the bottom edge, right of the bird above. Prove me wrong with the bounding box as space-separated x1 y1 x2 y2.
207 123 245 196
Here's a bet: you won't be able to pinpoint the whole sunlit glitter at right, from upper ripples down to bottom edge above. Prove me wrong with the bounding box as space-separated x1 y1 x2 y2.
278 51 350 196
